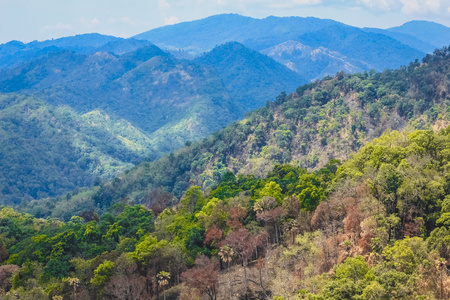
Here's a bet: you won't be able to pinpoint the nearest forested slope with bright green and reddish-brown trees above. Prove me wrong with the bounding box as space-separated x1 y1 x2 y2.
0 129 450 300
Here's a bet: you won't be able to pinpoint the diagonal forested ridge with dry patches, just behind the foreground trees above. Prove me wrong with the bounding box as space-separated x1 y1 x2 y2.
28 48 450 217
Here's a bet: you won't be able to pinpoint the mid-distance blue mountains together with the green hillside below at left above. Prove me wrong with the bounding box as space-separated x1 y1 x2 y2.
0 40 306 203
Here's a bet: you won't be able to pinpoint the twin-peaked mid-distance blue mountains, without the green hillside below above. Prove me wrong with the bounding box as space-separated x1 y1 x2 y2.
0 41 305 156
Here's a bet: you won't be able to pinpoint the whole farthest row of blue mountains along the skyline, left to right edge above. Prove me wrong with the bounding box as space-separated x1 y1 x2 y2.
0 14 450 80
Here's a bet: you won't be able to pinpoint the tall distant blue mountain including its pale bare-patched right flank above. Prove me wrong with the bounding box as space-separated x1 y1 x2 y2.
134 14 426 80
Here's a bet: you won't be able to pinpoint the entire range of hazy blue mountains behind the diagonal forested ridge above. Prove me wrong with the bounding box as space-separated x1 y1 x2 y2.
0 14 448 203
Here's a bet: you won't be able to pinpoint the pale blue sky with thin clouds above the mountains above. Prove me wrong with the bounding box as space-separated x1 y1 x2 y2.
0 0 450 44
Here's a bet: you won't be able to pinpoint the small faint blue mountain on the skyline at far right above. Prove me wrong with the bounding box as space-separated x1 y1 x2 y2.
386 21 450 48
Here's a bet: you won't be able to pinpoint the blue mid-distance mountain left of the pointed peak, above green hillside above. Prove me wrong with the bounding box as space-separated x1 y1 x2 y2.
0 46 242 152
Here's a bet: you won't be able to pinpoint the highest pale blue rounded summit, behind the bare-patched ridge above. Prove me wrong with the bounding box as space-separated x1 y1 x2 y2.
134 14 340 54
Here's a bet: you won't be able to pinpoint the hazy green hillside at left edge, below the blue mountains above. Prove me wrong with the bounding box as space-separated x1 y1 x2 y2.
0 94 155 205
